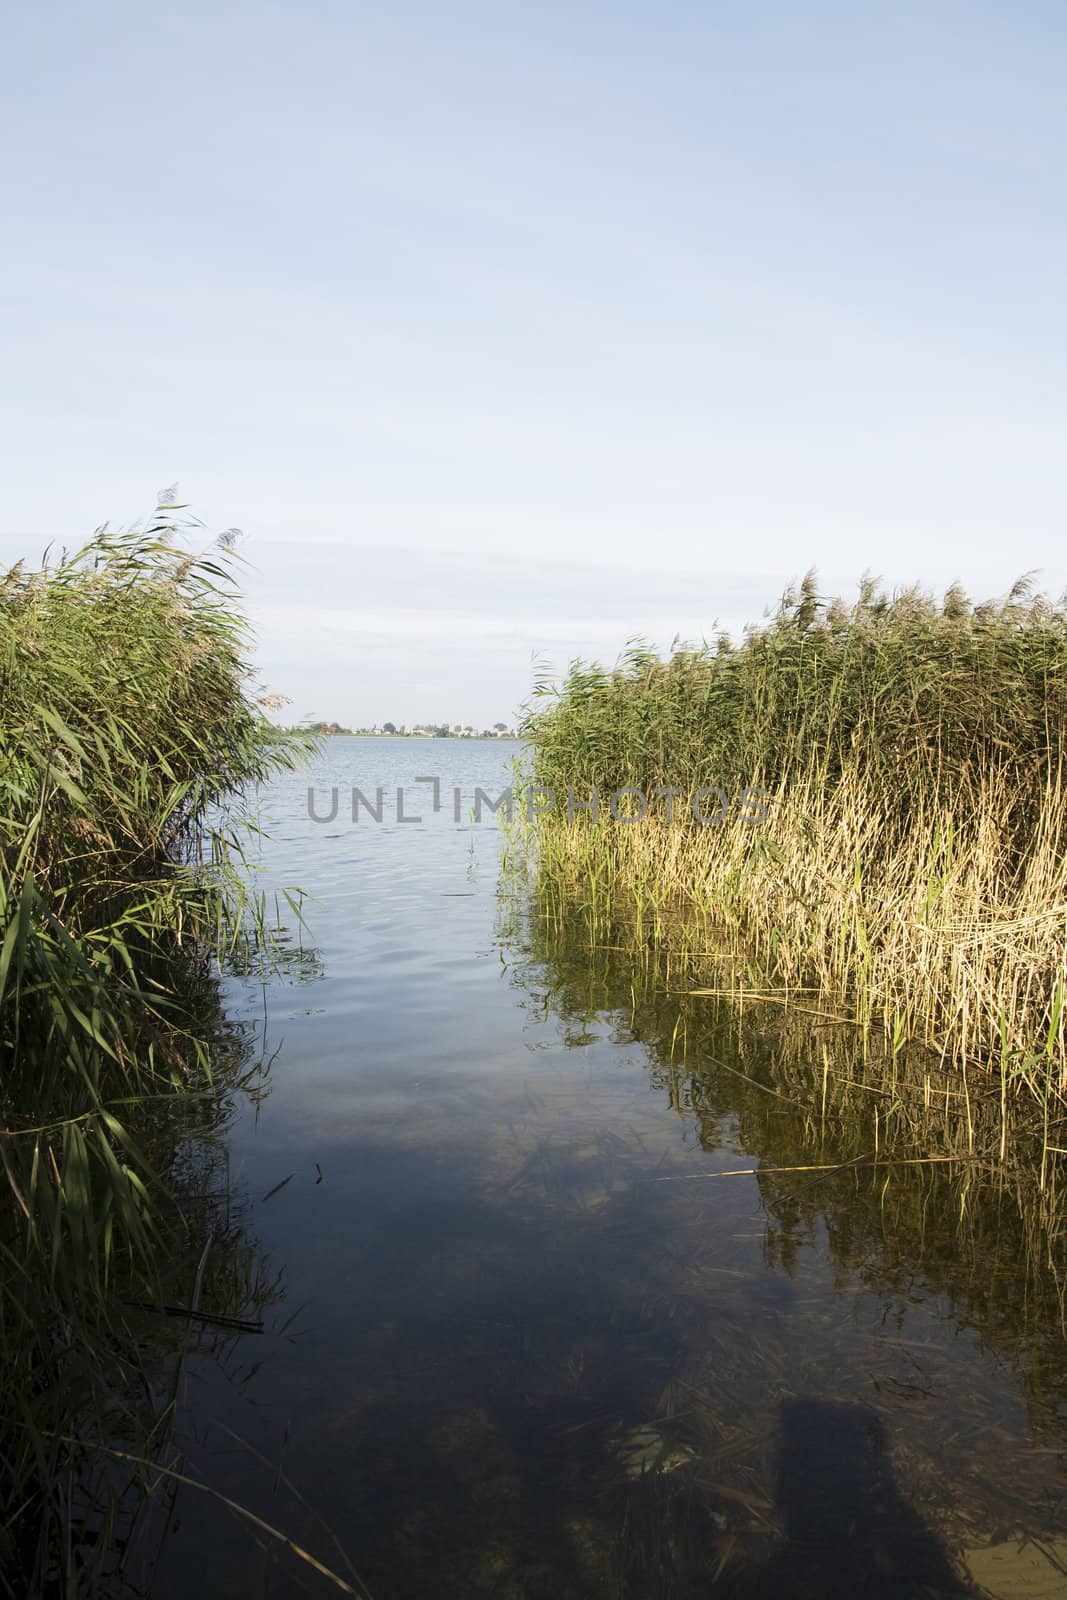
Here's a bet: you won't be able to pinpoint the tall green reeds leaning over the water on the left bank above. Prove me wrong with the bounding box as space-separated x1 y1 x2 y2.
0 506 313 1594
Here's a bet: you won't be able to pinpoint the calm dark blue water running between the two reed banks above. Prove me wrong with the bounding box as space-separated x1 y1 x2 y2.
141 739 1067 1600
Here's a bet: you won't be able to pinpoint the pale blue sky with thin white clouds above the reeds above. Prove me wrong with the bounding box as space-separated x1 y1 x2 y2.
0 0 1067 725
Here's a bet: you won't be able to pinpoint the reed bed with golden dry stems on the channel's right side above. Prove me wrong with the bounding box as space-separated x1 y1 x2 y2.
522 574 1067 1147
